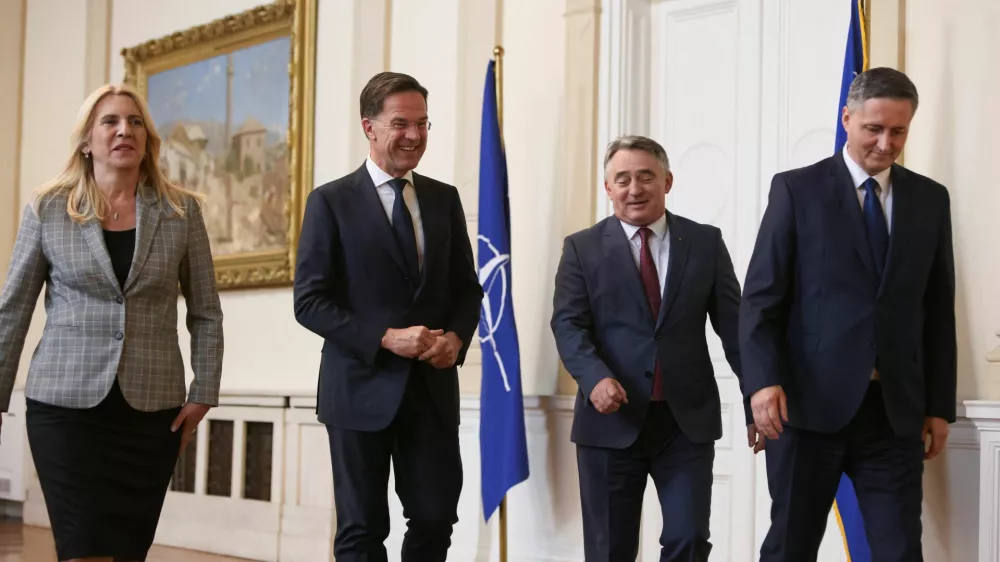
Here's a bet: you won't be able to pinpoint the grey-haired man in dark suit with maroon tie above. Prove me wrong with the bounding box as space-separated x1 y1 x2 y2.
551 136 756 562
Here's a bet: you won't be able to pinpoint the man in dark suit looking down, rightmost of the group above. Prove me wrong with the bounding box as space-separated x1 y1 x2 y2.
740 68 956 562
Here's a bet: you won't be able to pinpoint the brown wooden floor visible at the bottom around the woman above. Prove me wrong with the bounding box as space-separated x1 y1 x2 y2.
0 519 254 562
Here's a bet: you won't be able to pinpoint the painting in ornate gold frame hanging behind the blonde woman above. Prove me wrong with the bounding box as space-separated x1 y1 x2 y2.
121 0 317 289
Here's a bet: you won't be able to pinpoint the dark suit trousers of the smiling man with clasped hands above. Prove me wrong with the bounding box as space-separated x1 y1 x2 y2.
326 372 462 562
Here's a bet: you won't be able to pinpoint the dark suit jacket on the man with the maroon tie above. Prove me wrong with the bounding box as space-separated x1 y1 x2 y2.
551 213 749 449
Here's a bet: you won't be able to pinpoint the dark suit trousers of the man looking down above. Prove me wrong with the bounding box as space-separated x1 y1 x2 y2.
760 381 924 562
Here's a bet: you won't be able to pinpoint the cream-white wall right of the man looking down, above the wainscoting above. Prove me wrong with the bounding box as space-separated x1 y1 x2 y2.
904 0 1000 399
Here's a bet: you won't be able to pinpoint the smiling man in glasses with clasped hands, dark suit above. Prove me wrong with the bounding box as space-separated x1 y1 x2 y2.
295 72 483 562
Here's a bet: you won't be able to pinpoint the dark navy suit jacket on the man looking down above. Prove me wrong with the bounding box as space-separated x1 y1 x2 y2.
740 153 956 437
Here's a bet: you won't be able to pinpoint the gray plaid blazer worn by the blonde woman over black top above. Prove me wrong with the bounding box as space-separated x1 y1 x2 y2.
0 188 223 412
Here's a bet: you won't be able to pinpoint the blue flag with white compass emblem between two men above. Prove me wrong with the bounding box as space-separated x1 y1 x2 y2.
478 60 528 521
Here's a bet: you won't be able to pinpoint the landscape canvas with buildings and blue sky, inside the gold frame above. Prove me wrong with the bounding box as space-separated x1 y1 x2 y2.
147 37 291 255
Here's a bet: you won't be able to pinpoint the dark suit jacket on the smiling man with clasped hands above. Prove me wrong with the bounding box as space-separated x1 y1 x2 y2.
294 165 483 431
